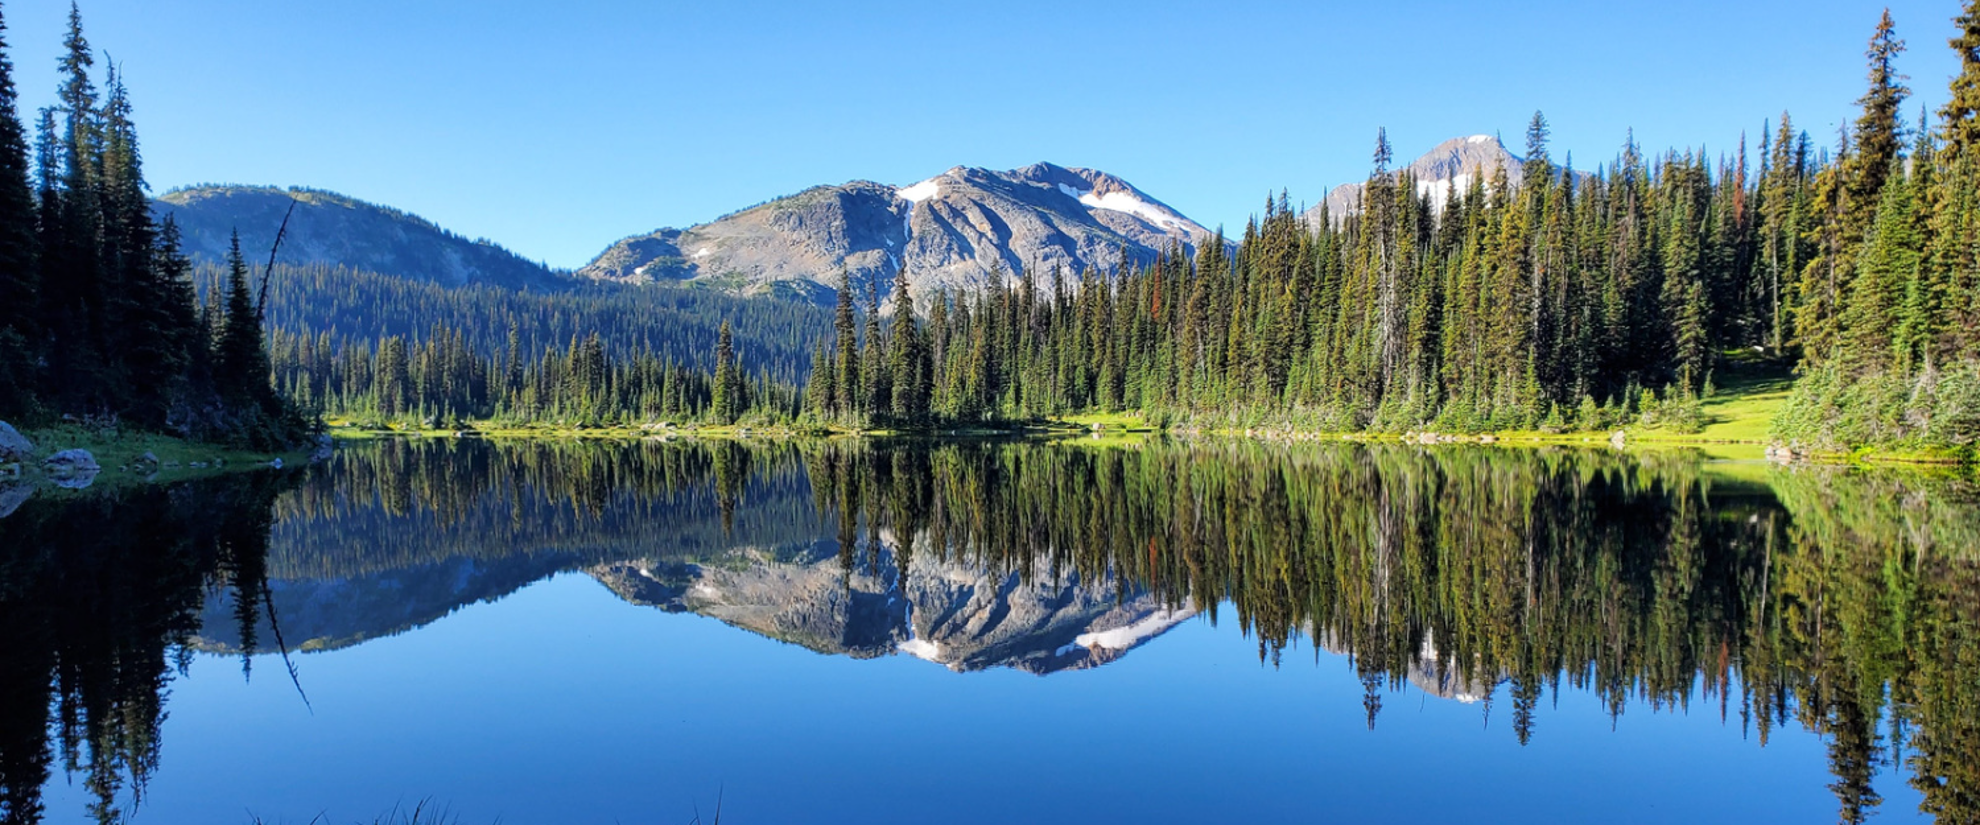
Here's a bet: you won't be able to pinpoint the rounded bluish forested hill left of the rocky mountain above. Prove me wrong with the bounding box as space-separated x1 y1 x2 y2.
152 186 572 291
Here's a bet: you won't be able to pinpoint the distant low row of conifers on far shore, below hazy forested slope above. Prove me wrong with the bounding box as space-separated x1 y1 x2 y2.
271 322 780 427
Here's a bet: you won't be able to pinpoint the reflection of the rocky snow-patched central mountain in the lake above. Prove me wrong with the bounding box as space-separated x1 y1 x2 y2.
590 544 1194 675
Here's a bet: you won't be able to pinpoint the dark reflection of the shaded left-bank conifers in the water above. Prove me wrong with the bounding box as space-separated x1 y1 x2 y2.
0 475 283 823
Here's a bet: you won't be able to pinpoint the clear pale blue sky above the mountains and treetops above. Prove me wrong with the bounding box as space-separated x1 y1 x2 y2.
4 0 1960 267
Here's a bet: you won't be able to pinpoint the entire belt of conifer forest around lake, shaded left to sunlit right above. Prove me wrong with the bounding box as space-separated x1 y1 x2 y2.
0 4 1980 457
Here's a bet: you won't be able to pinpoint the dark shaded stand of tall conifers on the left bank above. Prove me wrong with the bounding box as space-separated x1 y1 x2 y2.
0 6 309 449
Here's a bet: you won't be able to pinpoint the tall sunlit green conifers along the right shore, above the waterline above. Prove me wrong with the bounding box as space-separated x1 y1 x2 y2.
806 4 1980 445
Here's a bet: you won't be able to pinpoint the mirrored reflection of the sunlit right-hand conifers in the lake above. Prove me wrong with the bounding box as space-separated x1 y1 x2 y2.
802 441 1980 823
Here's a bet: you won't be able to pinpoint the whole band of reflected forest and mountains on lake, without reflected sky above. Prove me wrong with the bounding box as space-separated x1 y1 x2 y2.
0 439 1980 823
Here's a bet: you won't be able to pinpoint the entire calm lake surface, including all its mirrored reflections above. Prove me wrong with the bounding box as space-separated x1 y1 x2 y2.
0 441 1980 825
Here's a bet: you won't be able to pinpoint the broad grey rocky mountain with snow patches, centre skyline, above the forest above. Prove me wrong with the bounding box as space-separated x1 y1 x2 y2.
578 162 1212 301
